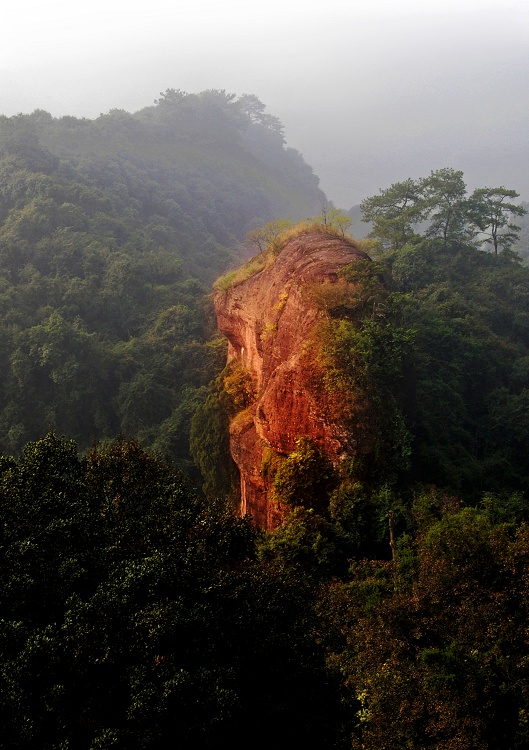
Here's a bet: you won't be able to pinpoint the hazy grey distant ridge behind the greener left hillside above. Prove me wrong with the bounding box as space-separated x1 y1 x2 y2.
0 89 326 280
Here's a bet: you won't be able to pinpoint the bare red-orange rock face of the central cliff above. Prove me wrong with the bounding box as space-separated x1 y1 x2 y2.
215 232 368 528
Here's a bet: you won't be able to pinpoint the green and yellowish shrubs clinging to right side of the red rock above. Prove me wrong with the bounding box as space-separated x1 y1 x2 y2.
313 260 414 486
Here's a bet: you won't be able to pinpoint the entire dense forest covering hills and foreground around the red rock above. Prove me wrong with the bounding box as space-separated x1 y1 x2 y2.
0 97 529 750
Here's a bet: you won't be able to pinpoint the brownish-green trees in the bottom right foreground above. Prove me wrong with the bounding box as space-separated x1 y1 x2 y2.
321 502 529 750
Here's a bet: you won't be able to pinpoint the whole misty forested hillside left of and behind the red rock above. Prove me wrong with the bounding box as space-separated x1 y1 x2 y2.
0 90 324 468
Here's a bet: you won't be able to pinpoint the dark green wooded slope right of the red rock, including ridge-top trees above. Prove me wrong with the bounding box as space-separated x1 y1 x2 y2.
356 170 529 502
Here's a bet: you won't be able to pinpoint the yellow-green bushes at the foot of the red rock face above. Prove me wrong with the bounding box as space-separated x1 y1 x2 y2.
260 438 406 580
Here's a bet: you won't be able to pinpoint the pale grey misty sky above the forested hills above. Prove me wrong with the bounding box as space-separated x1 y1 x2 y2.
0 0 529 208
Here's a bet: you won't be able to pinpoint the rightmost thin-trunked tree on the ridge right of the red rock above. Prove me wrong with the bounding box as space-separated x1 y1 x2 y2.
470 187 527 256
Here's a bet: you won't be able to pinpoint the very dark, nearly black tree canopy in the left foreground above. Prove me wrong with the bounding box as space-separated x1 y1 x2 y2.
0 435 341 750
